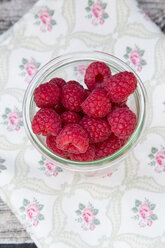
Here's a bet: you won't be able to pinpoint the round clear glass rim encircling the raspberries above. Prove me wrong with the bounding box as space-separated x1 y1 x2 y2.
23 51 148 171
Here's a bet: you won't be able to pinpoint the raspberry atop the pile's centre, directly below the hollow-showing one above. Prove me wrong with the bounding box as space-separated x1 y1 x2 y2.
81 89 111 118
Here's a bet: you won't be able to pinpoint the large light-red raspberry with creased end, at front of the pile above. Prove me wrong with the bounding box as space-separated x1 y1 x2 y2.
56 124 89 154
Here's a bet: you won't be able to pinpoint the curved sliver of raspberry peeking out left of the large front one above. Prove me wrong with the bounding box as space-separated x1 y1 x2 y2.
46 135 68 158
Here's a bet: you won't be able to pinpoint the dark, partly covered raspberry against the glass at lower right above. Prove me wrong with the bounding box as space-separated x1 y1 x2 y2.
95 134 125 159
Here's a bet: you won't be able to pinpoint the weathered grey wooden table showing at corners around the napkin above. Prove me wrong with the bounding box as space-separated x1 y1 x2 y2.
0 0 165 248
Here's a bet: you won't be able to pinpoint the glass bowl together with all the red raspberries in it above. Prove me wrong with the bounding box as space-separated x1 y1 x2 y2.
23 52 147 172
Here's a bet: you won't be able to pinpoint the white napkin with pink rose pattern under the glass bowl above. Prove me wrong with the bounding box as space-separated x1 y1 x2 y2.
0 0 165 248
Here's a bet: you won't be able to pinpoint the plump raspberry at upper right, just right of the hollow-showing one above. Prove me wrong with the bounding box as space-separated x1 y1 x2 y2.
104 71 137 103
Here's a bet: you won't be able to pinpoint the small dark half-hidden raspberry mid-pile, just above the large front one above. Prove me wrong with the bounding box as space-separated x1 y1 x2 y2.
61 111 81 126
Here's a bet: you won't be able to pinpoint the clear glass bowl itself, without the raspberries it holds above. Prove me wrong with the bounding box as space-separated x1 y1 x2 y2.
23 52 148 172
